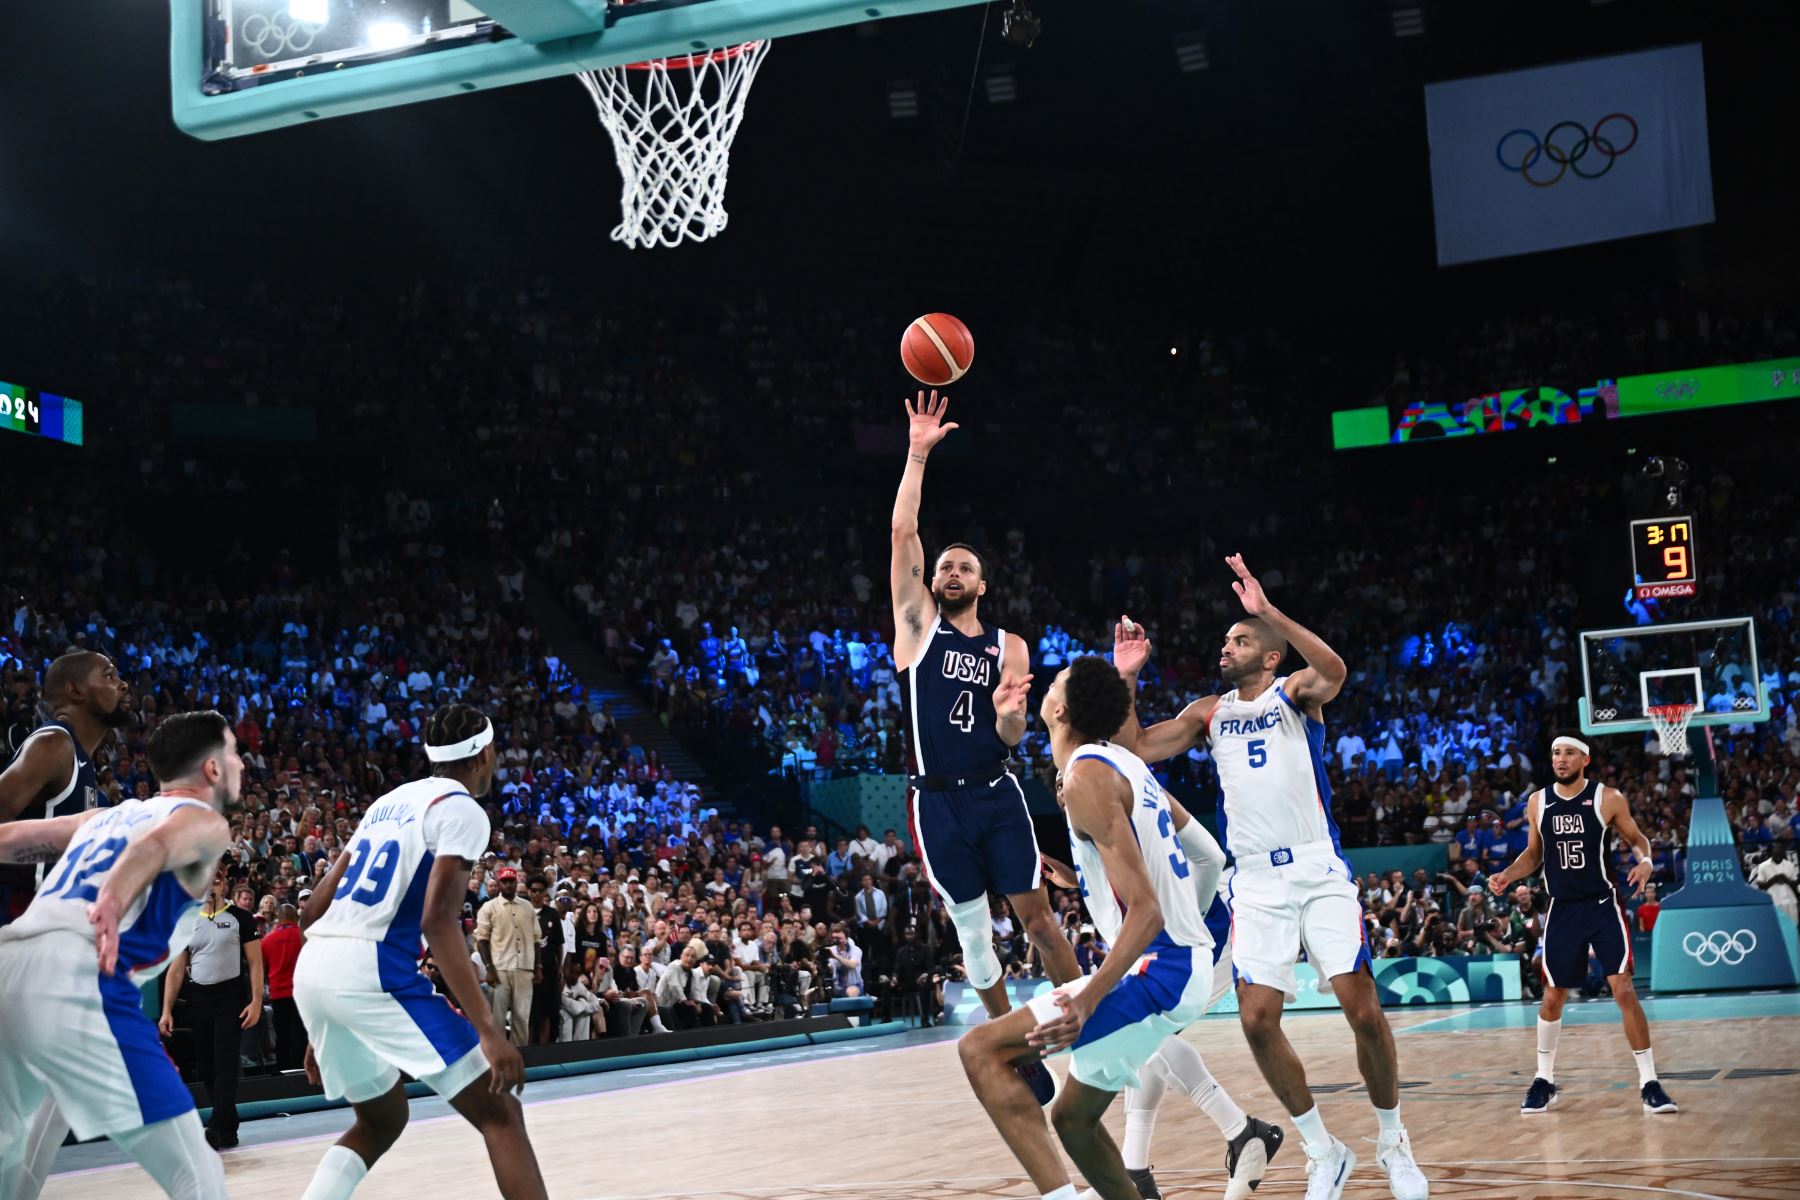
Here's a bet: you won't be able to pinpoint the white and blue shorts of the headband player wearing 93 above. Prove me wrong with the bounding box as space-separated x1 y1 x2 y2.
293 937 488 1105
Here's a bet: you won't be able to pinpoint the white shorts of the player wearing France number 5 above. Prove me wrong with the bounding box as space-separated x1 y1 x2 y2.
1226 840 1370 1000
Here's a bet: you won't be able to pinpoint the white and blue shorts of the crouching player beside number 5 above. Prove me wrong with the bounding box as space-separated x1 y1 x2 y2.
1030 936 1213 1092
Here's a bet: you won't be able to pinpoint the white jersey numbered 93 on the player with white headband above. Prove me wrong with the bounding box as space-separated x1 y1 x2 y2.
306 775 488 966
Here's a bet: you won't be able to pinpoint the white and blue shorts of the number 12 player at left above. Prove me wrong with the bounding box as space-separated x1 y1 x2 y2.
0 930 194 1160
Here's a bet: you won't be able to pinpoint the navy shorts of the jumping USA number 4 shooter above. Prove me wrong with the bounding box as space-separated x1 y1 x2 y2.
907 775 1042 905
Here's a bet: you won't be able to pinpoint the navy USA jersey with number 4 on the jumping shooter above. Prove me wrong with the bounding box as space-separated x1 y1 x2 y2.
900 617 1012 775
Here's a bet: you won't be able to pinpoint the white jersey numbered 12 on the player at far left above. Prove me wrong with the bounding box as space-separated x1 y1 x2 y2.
0 795 211 982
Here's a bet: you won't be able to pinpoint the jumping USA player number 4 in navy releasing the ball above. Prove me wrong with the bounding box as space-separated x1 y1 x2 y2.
891 390 1080 1103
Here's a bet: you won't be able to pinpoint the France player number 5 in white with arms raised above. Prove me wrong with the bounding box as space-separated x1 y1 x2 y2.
1112 554 1429 1200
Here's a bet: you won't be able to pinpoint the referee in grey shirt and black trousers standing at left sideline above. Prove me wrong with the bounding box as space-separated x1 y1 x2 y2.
160 865 263 1150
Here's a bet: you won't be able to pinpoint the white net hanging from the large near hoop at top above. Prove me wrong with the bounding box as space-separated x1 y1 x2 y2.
580 40 770 248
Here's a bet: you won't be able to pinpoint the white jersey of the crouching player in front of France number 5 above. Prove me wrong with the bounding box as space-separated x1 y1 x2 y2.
1069 741 1213 948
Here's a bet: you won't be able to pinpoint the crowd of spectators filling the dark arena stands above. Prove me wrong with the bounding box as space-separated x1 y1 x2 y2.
0 271 1800 1086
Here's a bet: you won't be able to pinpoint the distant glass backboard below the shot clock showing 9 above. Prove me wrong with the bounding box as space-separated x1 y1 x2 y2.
1579 617 1769 734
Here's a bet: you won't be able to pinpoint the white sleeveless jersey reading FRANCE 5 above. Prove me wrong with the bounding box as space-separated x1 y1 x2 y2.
1206 675 1343 858
